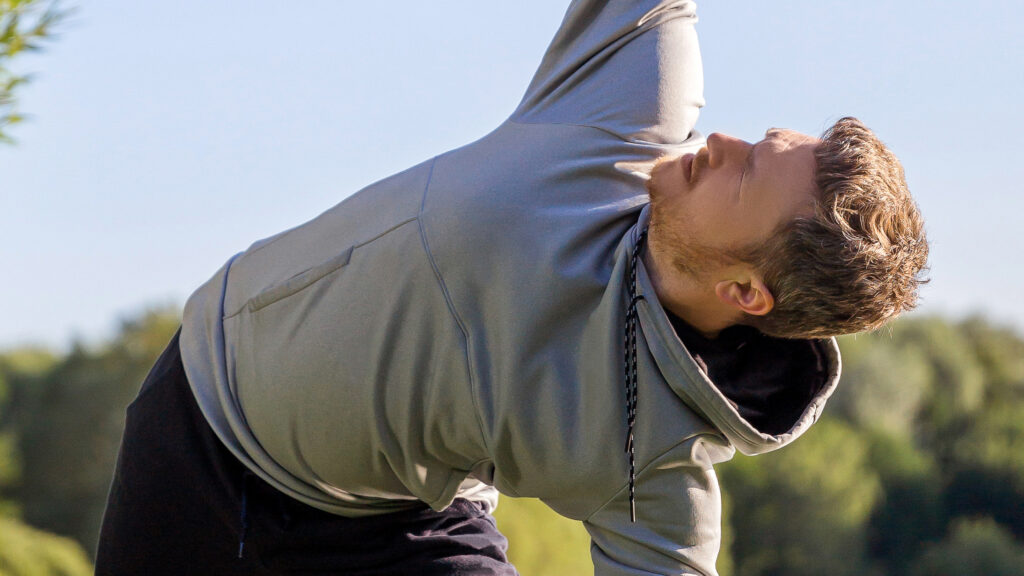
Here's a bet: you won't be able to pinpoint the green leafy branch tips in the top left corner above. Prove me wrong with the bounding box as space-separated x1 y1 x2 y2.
0 0 68 142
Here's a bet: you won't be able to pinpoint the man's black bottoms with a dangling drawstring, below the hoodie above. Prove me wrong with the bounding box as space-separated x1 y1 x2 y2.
96 327 516 576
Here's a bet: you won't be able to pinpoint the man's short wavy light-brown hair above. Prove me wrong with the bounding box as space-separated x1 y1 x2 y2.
744 117 928 338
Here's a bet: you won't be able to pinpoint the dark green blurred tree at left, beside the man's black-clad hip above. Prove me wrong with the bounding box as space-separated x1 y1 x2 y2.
9 311 179 550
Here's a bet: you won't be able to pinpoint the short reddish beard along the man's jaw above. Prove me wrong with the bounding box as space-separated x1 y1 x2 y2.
645 162 739 281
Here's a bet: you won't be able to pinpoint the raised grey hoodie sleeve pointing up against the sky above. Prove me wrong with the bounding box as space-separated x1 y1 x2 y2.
512 0 703 145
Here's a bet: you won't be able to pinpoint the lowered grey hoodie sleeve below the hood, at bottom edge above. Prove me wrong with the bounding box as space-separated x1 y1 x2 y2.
584 437 722 576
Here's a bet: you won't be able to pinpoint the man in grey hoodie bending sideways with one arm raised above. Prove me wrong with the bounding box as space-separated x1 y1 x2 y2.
97 0 927 576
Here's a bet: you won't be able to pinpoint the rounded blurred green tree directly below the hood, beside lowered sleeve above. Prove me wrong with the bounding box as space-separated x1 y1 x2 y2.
719 418 880 576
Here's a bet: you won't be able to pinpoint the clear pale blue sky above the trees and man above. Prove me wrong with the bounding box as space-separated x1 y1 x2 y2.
0 0 1024 349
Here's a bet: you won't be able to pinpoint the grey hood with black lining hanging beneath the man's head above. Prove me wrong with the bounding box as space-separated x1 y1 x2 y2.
628 205 842 455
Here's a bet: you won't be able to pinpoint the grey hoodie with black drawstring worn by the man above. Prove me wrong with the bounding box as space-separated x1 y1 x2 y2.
181 0 840 576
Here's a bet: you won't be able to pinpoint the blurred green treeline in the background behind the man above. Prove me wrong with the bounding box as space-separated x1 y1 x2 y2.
0 311 1024 576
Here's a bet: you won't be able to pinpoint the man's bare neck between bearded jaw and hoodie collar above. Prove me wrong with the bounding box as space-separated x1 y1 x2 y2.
643 245 738 338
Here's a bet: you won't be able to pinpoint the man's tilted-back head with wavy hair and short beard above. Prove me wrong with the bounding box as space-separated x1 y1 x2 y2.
648 118 928 337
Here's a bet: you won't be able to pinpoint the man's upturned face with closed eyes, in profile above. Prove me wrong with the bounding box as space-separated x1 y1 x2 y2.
647 128 819 277
